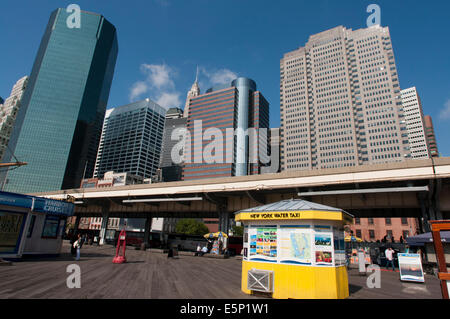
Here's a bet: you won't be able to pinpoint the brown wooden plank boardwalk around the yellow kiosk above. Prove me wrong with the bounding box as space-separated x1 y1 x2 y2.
0 245 441 299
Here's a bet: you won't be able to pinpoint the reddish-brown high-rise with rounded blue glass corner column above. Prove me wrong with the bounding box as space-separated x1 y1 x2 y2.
183 78 269 180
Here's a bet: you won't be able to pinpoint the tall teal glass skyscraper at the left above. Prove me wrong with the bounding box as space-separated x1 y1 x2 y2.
1 9 118 193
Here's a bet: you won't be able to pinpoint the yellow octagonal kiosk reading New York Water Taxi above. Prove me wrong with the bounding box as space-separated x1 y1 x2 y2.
235 199 353 299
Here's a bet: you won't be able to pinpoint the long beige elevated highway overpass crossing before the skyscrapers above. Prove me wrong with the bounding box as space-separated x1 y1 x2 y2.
33 158 450 238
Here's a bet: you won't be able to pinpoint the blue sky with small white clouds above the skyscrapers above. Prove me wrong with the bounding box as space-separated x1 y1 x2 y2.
0 0 450 156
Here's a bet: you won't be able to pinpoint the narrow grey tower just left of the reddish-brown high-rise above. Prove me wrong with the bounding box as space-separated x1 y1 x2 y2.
159 108 187 182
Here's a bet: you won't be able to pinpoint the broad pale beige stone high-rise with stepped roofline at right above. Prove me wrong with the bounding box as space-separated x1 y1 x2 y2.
280 26 410 170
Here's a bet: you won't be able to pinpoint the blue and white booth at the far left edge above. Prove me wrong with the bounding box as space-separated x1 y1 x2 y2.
0 192 74 259
